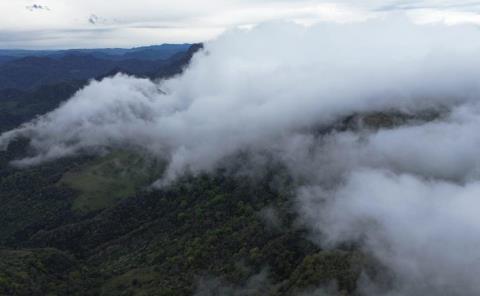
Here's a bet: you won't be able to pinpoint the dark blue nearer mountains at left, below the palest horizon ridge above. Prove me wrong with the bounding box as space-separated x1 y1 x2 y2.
0 45 202 132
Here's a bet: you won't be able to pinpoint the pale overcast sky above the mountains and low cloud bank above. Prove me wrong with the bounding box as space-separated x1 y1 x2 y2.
0 0 480 49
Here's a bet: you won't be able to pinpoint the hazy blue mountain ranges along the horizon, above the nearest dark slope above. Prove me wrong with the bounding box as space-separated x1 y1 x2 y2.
0 44 197 90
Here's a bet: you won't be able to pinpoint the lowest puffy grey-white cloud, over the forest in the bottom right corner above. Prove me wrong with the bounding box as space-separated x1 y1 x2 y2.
301 170 480 295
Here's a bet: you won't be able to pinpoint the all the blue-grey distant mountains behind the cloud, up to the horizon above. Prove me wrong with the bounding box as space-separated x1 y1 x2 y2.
0 44 202 132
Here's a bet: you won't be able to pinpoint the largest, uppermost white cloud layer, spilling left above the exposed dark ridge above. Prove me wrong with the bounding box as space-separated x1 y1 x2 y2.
0 19 480 176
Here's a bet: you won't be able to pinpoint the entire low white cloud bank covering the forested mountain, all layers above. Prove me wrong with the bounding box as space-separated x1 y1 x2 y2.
0 18 480 295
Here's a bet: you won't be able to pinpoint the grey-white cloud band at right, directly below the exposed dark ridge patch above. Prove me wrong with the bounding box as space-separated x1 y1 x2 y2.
282 104 480 183
